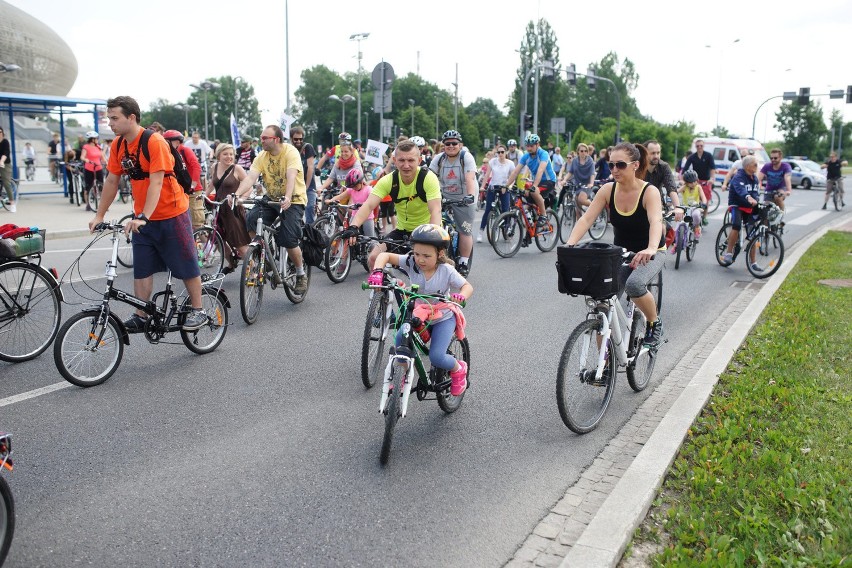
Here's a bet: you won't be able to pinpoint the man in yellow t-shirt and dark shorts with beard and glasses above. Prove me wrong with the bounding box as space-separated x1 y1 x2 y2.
236 124 308 294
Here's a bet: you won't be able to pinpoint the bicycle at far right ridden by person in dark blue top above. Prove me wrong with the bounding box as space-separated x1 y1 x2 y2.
715 203 784 278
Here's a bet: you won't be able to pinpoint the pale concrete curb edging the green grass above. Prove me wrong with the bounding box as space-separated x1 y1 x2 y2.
559 214 849 568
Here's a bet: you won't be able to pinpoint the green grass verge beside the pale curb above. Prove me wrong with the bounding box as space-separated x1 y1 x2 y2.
637 232 852 566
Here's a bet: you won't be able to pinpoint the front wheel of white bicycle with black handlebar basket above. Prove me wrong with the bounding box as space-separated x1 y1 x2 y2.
556 320 615 434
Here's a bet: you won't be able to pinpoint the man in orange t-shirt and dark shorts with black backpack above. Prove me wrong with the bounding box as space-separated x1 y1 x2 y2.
89 97 207 333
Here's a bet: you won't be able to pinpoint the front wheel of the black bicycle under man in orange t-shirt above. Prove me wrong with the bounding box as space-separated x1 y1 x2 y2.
53 311 124 387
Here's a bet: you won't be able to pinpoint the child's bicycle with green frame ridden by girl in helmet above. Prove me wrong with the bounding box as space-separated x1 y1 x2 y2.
361 266 470 465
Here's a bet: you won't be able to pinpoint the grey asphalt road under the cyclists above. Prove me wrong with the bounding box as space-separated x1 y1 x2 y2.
0 185 839 567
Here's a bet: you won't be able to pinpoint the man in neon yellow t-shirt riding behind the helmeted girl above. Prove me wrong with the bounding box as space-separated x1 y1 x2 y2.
342 140 441 266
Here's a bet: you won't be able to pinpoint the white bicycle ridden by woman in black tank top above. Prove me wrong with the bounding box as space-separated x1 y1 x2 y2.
556 246 662 434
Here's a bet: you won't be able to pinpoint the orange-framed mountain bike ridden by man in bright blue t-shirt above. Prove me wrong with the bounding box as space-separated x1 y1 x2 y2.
491 186 559 258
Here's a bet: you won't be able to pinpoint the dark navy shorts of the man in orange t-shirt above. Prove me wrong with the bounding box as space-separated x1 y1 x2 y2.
133 211 201 280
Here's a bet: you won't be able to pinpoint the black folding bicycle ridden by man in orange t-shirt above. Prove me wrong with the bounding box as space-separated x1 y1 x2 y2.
53 223 230 387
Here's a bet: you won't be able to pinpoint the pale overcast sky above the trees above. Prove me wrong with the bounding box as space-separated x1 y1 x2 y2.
9 0 852 139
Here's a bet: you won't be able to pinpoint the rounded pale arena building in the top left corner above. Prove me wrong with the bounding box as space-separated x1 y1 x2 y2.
0 0 77 97
